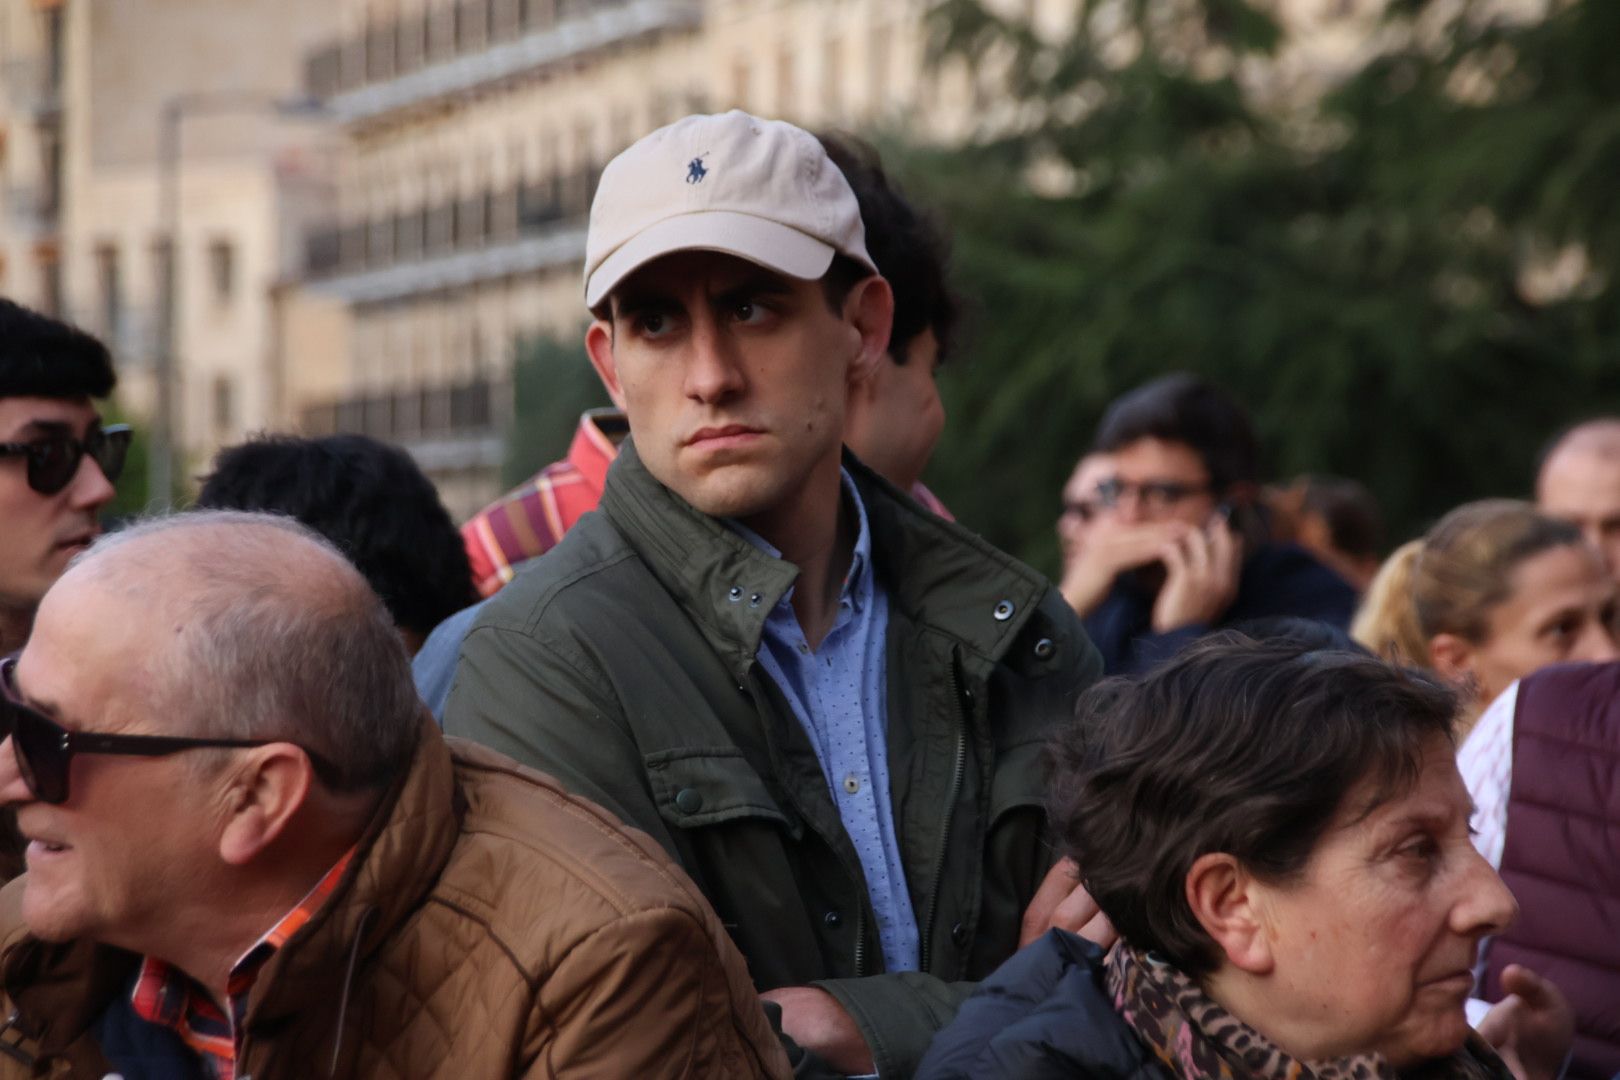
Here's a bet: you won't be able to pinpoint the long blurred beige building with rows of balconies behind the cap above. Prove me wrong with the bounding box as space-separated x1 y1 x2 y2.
282 0 997 515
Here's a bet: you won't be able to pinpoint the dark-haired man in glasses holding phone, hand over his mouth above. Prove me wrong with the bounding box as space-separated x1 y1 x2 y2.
1063 374 1356 674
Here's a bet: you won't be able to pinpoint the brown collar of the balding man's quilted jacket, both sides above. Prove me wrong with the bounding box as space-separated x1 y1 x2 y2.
0 714 462 1059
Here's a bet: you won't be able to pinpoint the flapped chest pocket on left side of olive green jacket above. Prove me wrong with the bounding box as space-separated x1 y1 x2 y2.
645 746 800 837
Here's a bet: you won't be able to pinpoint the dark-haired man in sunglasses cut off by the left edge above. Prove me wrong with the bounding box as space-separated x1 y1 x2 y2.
0 298 130 656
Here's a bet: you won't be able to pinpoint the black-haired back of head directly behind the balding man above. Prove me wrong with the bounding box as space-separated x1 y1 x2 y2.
196 436 478 635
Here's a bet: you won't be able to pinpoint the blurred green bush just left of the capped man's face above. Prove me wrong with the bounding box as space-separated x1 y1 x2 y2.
501 337 609 487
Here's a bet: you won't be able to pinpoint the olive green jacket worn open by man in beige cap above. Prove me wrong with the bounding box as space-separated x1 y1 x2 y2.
446 442 1102 1080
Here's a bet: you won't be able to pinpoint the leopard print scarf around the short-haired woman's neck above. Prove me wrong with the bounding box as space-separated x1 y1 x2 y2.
1106 942 1513 1080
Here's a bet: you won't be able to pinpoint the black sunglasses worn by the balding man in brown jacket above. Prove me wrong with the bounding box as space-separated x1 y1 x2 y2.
0 656 337 803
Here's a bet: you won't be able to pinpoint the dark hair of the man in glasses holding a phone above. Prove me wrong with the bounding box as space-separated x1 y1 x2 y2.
1092 372 1260 495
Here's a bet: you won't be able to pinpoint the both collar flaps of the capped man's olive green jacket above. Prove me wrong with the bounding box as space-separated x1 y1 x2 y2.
601 437 1050 680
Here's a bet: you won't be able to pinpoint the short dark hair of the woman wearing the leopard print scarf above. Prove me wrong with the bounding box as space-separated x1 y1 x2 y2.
1048 631 1456 978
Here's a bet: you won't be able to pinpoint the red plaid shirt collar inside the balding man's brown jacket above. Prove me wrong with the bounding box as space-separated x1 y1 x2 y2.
130 848 355 1080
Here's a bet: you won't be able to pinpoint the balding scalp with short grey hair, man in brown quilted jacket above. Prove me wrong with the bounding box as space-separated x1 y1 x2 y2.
53 512 421 790
